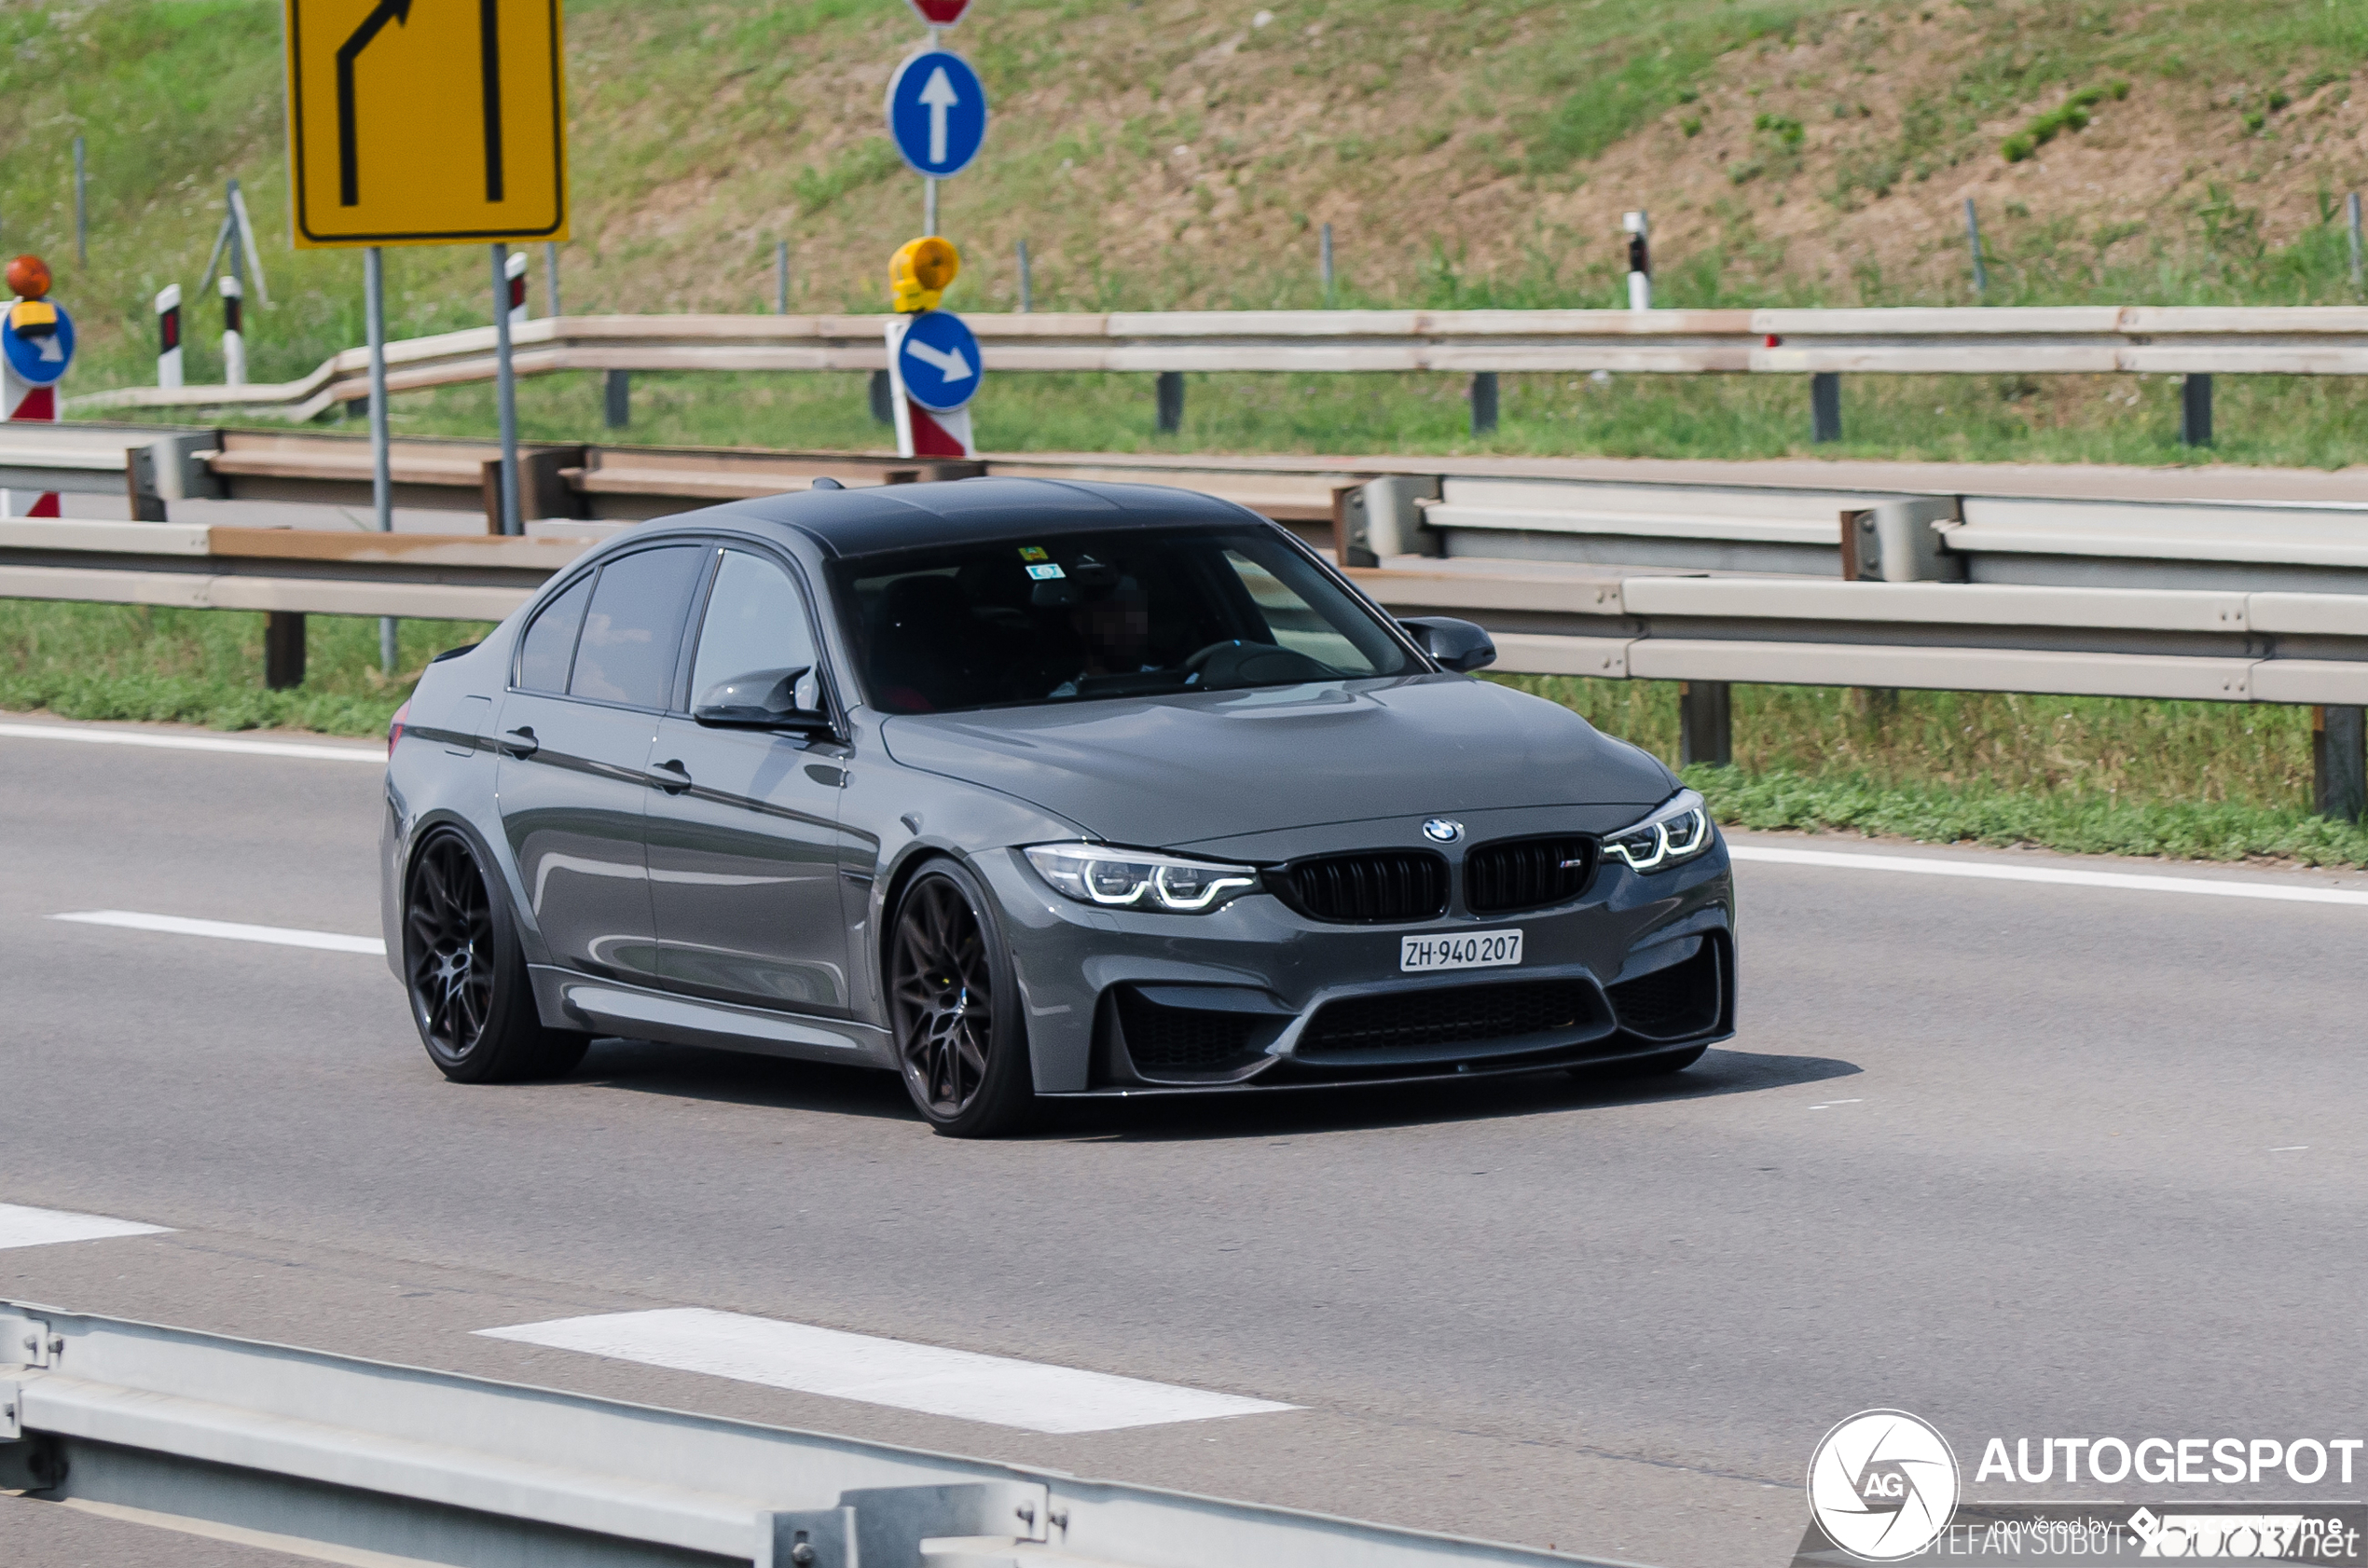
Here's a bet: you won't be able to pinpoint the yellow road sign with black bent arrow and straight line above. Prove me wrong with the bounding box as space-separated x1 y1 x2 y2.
286 0 569 249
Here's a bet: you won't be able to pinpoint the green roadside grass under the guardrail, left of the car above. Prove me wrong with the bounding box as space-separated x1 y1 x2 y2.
0 599 486 735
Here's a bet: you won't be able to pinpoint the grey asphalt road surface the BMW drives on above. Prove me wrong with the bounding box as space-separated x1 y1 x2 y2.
0 715 2368 1568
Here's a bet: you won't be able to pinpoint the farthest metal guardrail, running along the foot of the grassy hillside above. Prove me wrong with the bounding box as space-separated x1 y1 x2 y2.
66 306 2368 420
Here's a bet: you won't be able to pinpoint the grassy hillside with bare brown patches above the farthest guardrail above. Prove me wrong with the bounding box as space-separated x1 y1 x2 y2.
0 0 2368 386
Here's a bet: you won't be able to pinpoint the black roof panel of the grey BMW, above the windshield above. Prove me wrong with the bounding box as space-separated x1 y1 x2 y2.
695 478 1264 557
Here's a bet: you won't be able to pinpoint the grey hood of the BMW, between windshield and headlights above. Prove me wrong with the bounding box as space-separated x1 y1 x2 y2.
881 675 1676 848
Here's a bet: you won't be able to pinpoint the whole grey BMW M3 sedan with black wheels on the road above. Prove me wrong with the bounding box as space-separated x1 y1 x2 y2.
381 478 1736 1137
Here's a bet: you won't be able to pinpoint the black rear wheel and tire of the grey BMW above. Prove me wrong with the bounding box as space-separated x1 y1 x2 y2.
403 827 592 1082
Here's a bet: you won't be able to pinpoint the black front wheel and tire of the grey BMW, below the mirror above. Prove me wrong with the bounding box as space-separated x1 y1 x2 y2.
888 860 1038 1137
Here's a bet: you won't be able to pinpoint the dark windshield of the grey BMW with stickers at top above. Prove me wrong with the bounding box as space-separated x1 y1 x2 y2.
838 529 1416 713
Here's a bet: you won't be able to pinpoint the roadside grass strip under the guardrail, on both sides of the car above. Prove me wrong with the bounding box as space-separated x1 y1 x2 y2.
0 601 2368 864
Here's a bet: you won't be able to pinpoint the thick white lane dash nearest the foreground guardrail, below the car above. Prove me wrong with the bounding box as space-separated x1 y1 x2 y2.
478 1308 1298 1433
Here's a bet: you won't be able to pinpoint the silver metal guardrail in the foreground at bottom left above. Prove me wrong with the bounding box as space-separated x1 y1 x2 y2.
0 1302 1629 1568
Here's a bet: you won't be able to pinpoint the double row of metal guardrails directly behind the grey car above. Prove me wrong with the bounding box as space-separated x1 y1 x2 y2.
0 426 2368 815
